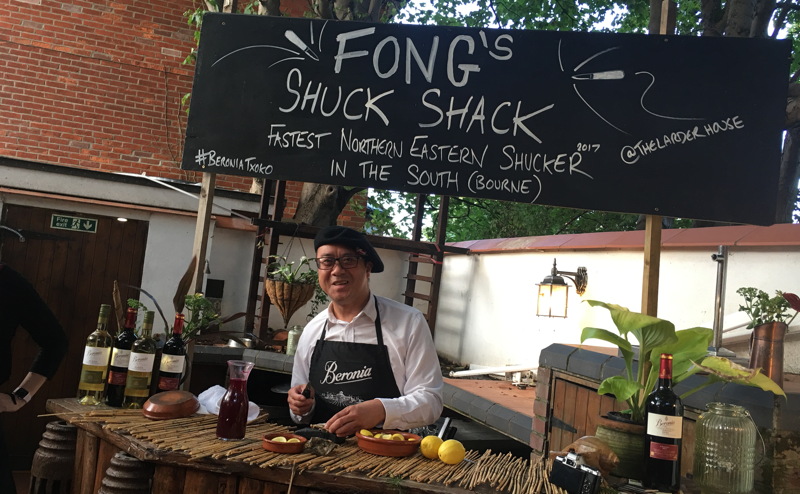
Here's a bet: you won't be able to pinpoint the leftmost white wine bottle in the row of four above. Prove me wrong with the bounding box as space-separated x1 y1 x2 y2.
78 304 114 405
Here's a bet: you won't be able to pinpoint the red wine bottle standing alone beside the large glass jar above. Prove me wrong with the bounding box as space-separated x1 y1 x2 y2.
644 353 683 492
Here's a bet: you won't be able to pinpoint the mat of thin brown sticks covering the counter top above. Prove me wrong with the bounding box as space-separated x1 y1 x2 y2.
54 410 563 494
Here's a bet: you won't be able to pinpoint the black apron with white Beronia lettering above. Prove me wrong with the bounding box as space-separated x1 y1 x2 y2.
308 297 400 423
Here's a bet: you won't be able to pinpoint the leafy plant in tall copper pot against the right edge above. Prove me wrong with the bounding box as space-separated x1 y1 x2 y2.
736 287 800 385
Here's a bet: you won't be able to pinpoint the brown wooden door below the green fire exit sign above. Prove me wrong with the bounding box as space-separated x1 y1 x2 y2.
0 204 148 470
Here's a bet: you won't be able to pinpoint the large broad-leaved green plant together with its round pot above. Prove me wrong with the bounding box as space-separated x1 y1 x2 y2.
581 300 786 478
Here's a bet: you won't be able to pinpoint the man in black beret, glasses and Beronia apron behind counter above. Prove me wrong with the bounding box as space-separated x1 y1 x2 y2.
287 226 443 436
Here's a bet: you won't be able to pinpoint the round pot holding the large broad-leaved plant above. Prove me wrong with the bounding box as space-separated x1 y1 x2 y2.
595 412 645 480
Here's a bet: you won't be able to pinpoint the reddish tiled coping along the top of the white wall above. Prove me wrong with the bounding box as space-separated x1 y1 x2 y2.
448 223 800 252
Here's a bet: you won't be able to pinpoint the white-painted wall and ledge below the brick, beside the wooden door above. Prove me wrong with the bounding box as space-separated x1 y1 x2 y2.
0 167 259 340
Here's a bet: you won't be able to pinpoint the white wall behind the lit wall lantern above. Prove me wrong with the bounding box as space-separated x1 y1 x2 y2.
428 246 800 372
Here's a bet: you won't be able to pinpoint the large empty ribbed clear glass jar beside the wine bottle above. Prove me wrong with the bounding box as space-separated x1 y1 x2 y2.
693 403 758 494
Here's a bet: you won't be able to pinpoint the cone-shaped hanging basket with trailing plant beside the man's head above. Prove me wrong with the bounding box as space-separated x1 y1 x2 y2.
264 255 318 329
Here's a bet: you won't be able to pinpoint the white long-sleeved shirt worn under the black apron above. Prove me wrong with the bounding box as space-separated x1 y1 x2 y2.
289 295 444 429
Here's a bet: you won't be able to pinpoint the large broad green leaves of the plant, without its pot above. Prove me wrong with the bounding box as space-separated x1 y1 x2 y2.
581 300 786 424
